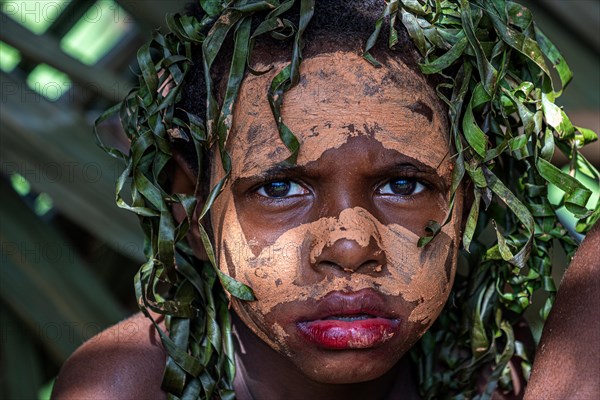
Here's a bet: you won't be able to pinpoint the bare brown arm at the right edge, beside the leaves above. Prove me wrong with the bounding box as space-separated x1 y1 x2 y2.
525 224 600 400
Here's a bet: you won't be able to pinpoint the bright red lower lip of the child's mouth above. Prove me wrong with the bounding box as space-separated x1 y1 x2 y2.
298 318 400 350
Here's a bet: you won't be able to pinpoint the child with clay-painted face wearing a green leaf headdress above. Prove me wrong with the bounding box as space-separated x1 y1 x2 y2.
55 0 597 399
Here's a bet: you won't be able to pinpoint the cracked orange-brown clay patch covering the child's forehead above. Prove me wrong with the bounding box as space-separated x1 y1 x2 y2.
229 52 449 179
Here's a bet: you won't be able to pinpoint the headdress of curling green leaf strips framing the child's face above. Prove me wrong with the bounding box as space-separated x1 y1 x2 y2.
97 0 600 399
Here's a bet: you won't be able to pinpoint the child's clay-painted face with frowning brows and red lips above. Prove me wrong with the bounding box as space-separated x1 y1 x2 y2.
211 53 461 383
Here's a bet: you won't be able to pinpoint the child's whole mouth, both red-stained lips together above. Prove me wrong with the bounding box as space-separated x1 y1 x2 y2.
296 289 400 350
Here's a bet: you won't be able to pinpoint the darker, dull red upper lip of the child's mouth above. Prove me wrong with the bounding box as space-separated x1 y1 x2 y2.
298 289 398 322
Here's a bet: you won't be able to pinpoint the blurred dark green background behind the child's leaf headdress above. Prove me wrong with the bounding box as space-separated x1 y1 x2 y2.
0 0 600 399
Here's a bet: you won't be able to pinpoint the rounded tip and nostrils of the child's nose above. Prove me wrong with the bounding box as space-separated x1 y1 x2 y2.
313 237 386 274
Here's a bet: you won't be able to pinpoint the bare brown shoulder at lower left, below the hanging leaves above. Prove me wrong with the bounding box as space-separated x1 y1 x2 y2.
52 313 166 400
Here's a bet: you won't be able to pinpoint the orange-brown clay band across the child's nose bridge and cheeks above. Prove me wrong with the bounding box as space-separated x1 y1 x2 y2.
220 204 454 350
